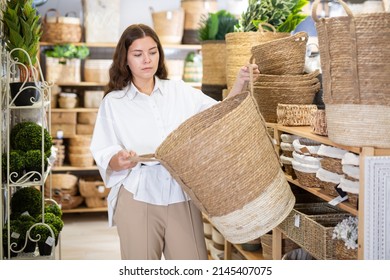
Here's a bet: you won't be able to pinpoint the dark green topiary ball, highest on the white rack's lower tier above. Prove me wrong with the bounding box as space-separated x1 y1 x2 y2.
11 187 42 220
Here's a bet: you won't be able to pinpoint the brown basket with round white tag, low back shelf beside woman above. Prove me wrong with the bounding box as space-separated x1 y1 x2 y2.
79 178 110 208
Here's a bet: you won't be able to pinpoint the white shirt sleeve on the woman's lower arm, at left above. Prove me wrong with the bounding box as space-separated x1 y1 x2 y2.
90 100 130 188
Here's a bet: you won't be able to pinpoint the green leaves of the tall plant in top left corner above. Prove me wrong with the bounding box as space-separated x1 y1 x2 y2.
2 0 42 65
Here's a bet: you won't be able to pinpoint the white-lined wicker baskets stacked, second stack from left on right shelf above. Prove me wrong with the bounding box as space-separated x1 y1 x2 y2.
292 138 321 188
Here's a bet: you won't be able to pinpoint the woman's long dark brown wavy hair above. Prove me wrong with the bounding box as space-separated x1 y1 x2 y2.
105 24 168 95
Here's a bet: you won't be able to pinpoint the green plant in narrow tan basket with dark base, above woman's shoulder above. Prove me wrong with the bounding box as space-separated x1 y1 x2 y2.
198 10 238 100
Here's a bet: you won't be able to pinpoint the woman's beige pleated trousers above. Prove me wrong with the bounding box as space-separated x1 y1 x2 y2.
114 186 207 260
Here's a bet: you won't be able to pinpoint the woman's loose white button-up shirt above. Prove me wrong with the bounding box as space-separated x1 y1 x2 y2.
90 77 217 225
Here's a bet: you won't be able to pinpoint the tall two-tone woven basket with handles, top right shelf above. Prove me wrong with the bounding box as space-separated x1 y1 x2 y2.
312 0 390 148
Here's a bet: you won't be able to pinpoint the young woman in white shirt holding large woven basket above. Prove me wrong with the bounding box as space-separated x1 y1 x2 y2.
91 24 259 260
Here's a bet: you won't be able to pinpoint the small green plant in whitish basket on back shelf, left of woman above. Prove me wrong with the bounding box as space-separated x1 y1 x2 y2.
43 44 90 83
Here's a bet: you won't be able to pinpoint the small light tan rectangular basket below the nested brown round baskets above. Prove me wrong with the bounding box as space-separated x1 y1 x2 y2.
276 104 317 126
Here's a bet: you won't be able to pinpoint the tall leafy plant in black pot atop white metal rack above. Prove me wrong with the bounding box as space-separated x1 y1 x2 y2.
2 0 42 106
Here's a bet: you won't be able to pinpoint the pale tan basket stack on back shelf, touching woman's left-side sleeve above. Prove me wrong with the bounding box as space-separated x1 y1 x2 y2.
68 136 94 167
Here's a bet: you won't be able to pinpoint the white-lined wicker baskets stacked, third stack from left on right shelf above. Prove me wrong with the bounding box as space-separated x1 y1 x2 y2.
316 144 347 197
